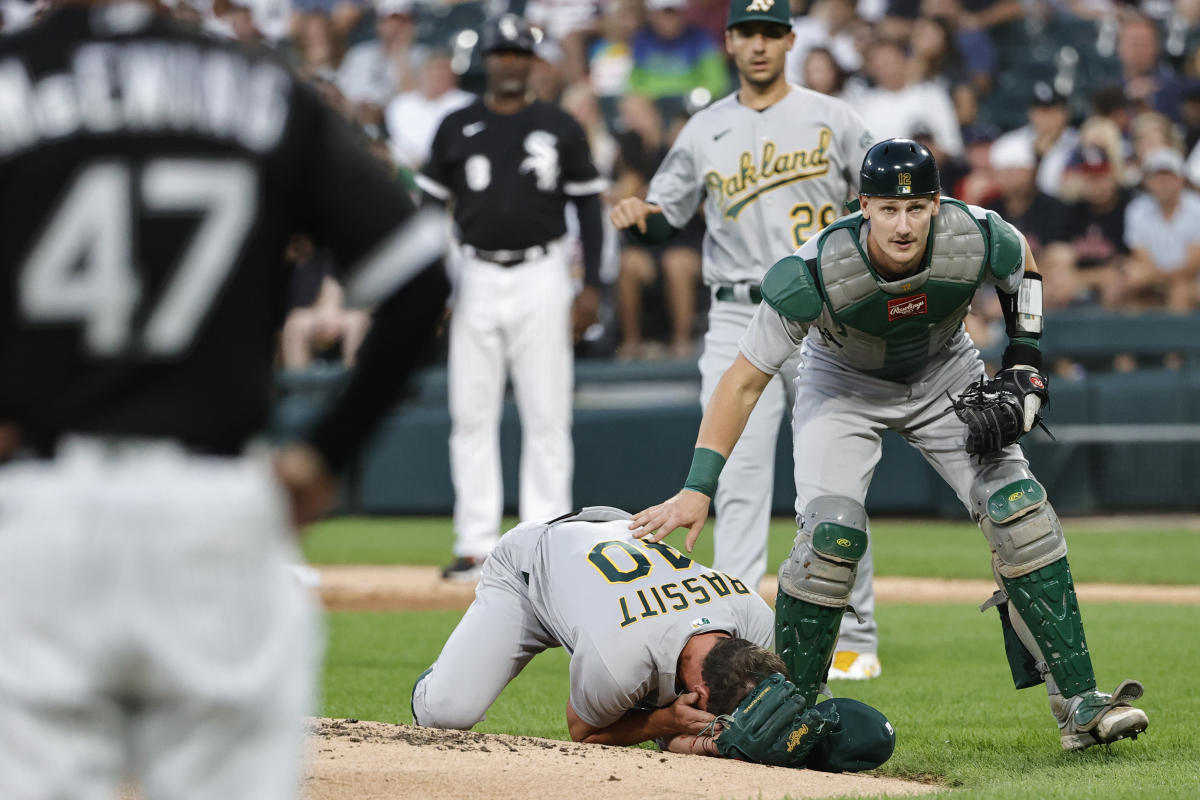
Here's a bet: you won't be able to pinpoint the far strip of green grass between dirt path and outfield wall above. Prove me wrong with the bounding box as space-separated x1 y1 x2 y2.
304 517 1200 585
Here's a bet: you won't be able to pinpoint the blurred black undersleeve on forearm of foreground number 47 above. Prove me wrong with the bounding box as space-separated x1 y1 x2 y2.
306 261 450 474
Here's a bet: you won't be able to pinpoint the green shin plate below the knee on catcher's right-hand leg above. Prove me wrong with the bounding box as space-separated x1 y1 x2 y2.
1003 558 1096 697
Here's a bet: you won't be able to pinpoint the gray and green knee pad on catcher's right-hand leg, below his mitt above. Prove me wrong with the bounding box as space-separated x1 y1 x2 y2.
971 477 1067 578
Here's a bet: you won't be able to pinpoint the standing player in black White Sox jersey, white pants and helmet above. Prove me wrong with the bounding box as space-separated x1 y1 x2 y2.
416 14 605 579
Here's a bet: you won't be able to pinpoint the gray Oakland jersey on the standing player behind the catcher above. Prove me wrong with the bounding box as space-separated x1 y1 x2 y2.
647 86 872 285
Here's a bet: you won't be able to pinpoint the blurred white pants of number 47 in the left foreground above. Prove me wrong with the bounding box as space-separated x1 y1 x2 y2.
0 439 318 800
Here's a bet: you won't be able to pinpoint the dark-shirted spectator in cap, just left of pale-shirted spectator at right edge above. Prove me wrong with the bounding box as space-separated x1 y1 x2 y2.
1060 144 1132 308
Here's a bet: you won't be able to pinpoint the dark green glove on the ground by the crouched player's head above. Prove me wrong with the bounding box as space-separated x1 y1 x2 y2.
716 673 838 766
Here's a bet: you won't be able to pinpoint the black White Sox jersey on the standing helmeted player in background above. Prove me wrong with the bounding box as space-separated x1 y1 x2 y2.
416 100 605 251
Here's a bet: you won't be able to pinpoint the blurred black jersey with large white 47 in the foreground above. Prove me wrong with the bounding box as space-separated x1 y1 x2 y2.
0 4 440 452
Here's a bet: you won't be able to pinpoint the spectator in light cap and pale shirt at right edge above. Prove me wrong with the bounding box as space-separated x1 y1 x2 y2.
1123 148 1200 312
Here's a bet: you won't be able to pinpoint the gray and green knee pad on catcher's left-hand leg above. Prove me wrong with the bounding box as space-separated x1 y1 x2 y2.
779 494 866 608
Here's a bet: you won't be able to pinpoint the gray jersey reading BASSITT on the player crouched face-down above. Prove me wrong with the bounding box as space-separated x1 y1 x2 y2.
529 506 774 727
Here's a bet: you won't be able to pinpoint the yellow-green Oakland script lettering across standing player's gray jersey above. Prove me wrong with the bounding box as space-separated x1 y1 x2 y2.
704 128 833 219
